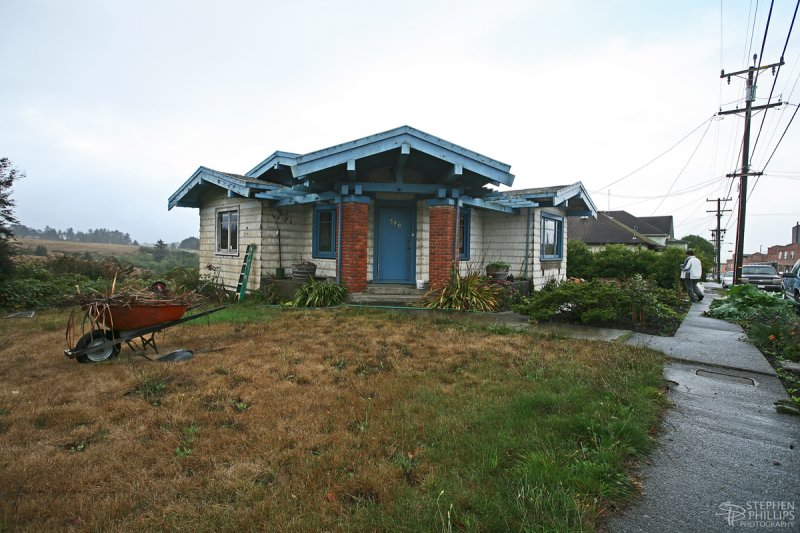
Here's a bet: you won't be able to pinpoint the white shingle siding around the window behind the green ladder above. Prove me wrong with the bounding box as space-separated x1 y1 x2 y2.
200 192 262 290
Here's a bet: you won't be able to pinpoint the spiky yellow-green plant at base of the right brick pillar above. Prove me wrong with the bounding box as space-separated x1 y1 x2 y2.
421 270 502 311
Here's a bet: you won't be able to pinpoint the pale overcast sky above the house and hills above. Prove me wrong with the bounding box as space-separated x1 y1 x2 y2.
0 0 800 258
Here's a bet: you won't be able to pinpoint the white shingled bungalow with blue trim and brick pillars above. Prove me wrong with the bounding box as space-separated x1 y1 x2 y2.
168 126 596 293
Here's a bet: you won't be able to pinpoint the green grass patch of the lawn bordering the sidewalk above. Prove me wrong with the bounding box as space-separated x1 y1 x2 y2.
340 341 666 531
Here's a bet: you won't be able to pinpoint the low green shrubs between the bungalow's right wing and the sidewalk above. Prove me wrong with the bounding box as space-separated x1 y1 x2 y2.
515 274 685 335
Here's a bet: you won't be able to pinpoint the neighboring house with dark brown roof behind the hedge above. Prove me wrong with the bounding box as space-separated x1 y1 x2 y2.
569 211 685 251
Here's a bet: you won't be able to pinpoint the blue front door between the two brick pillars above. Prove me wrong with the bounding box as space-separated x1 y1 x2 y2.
374 205 416 283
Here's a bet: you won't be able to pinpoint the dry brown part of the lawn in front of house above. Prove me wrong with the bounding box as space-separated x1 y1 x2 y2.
0 310 664 531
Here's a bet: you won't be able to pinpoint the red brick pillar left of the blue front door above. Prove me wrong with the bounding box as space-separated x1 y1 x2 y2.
340 202 369 292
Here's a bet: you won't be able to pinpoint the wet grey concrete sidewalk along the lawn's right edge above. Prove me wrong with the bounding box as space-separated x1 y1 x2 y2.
607 291 800 532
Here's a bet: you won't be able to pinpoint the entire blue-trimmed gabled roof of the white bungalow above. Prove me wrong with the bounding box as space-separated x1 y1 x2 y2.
168 126 597 217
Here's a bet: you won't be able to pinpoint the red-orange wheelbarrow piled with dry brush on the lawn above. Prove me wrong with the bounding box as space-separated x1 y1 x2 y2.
64 301 225 363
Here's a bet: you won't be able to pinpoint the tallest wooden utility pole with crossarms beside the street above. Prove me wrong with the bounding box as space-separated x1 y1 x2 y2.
717 54 783 285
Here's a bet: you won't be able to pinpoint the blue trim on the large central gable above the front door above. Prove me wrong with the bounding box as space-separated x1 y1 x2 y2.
292 126 514 186
